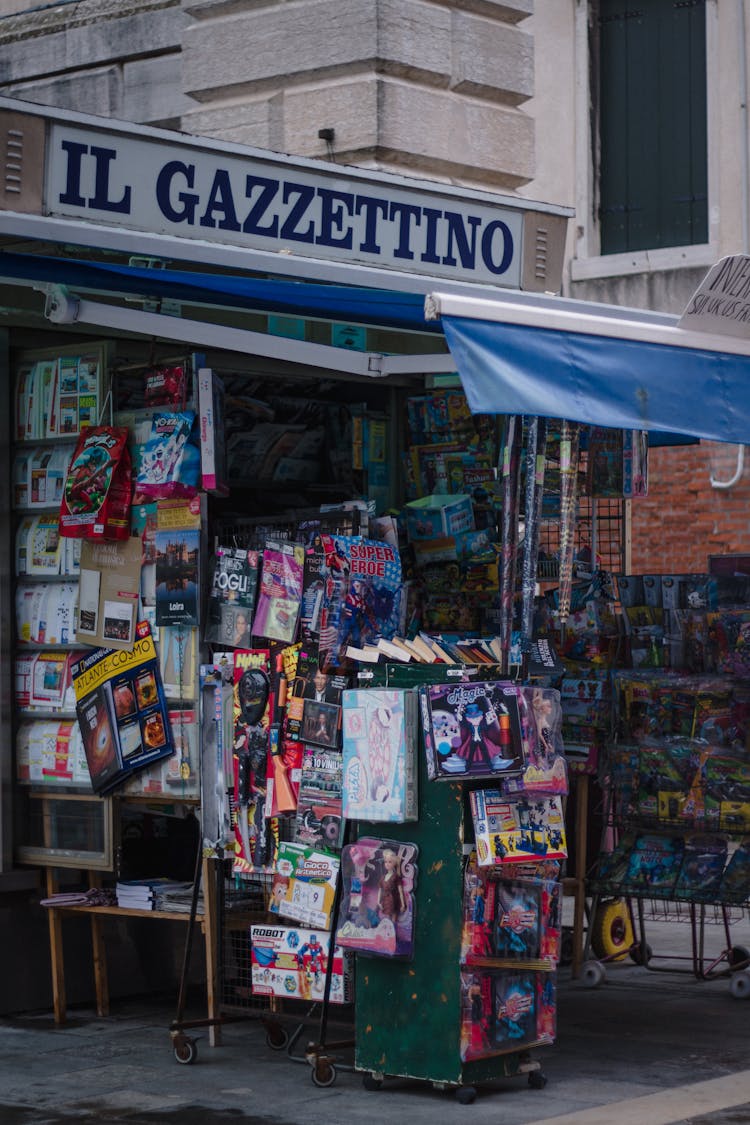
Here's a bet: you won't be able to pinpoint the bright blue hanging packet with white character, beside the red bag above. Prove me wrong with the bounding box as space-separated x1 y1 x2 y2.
136 411 200 500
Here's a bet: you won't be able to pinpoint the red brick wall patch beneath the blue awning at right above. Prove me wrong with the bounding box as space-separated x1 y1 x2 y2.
632 442 750 574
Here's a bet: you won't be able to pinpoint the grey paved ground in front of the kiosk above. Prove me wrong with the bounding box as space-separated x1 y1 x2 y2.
0 917 750 1125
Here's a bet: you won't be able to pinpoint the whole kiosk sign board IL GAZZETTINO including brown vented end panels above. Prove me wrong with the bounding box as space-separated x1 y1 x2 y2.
0 99 569 290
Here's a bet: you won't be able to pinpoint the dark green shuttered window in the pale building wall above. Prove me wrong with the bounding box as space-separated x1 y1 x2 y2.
596 0 708 254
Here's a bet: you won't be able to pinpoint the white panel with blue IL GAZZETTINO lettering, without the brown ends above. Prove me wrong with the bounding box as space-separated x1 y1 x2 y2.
45 123 524 288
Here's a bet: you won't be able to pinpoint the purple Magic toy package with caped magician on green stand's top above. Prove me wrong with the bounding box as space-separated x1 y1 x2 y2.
419 681 524 781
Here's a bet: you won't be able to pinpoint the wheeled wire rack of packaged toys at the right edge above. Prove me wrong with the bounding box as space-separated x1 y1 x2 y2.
582 672 750 997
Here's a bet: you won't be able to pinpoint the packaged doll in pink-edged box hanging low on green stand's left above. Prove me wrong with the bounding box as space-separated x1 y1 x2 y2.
336 836 418 959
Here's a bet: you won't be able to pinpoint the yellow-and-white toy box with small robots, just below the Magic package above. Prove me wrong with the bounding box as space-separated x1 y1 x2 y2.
469 789 568 866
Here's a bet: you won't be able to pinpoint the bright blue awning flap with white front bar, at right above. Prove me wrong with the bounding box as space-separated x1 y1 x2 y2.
426 294 750 443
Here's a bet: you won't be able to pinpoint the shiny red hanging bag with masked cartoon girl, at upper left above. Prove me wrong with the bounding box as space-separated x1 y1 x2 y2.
60 426 130 539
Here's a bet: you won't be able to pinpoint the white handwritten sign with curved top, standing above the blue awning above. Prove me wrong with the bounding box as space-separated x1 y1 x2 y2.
677 254 750 340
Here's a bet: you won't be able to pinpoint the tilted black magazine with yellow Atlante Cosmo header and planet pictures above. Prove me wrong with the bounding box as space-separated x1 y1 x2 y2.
71 621 174 794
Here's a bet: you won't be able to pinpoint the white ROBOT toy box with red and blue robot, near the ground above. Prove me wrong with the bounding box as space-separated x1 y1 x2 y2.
250 926 354 1004
